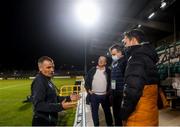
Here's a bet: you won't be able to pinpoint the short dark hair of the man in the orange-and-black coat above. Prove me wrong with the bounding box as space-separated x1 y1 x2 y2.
123 29 146 43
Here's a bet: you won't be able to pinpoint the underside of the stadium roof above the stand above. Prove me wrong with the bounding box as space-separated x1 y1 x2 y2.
88 0 179 55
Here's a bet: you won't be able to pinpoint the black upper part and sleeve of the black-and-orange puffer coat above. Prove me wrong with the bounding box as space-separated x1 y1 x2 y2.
121 43 159 120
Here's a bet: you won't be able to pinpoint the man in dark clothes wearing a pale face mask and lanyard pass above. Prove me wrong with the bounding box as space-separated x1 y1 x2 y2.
109 44 126 126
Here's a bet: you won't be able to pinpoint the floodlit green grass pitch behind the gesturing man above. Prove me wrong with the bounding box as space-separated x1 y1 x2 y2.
0 79 76 126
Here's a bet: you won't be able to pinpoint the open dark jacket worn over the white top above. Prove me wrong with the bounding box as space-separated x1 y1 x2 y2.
85 67 111 93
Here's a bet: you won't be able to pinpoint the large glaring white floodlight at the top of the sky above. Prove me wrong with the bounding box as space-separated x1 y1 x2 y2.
75 0 100 26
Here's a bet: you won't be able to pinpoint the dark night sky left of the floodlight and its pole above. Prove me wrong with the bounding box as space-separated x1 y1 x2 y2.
0 0 87 70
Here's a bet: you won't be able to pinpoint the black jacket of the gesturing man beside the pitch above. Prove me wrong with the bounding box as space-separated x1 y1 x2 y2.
31 73 70 121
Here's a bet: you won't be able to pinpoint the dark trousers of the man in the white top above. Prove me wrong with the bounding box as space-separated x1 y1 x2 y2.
90 94 113 126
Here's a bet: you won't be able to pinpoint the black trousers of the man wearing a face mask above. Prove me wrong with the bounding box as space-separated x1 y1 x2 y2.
112 91 123 126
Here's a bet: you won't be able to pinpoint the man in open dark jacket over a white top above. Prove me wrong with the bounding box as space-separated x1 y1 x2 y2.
85 56 113 126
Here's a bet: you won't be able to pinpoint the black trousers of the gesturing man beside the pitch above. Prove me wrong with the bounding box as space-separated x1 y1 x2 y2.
32 116 57 126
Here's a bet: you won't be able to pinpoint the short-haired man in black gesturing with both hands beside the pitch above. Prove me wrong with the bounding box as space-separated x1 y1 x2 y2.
31 56 79 126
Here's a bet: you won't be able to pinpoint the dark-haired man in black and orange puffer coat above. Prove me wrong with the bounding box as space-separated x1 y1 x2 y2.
121 29 159 126
